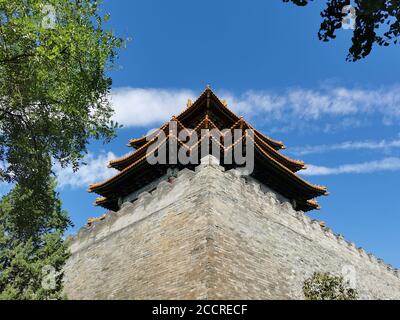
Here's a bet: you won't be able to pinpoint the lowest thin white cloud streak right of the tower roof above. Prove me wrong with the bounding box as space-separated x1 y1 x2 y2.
301 158 400 176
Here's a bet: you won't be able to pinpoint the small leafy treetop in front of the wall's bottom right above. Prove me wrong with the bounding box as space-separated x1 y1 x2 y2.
303 272 357 300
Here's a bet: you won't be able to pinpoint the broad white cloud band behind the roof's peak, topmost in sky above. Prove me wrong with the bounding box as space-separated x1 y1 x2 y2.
112 85 400 130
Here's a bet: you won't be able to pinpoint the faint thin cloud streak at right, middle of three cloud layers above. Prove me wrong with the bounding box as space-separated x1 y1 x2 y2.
290 139 400 156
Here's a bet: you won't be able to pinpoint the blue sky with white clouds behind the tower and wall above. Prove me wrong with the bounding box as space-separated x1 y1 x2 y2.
52 0 400 267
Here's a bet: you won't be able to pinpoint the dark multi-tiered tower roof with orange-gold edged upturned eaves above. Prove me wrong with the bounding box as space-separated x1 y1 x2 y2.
88 87 327 211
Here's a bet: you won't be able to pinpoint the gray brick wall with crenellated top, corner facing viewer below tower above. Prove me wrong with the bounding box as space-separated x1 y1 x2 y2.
64 158 400 299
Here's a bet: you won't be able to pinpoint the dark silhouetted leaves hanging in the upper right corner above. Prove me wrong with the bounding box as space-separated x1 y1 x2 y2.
283 0 400 61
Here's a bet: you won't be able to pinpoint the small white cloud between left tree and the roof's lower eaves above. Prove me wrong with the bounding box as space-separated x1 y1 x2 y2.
54 152 117 189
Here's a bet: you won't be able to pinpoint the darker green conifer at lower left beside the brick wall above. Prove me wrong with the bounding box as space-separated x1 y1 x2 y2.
0 176 71 299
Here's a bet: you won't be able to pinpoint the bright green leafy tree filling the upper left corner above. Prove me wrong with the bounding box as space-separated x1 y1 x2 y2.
0 0 124 189
